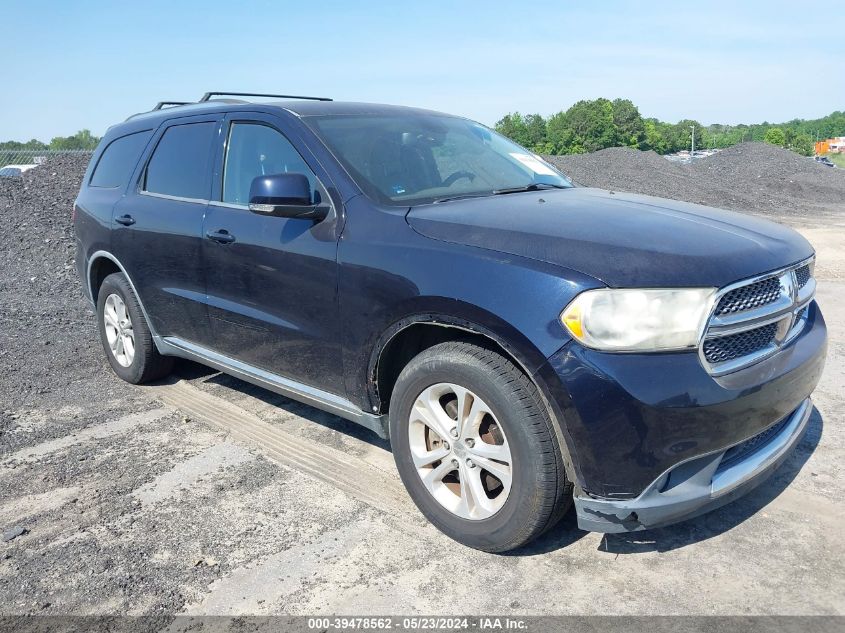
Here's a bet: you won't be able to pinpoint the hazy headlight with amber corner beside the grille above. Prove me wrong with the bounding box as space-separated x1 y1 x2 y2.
560 288 716 352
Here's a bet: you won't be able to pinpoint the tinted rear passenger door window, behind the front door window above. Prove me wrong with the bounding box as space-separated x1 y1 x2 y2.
143 121 217 200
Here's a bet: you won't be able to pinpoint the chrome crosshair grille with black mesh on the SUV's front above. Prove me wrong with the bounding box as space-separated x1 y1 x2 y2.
699 261 816 376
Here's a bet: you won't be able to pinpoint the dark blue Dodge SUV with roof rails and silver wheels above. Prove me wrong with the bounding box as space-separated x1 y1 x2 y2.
75 93 826 551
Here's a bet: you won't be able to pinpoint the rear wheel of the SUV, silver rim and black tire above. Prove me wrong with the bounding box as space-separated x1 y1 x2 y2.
97 273 173 385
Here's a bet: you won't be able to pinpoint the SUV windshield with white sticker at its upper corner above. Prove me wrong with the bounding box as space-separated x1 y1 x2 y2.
307 112 572 206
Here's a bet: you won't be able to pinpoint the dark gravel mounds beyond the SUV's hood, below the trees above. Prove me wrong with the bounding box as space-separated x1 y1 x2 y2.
545 143 845 224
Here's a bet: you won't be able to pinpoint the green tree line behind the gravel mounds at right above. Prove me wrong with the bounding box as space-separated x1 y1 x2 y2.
495 98 845 156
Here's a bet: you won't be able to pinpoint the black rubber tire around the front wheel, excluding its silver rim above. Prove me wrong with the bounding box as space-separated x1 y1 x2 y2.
390 354 544 551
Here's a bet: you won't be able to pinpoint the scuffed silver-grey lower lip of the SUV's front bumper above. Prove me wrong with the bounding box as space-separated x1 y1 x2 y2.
575 398 813 532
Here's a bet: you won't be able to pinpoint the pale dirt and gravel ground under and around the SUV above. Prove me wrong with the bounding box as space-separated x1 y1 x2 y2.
0 152 845 615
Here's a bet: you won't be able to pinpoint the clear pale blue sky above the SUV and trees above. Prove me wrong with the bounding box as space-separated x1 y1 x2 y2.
0 0 845 140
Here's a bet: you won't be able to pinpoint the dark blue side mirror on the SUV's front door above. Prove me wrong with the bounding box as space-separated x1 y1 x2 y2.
249 174 329 221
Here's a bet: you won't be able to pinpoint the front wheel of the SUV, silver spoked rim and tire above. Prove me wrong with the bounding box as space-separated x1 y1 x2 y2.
389 342 572 552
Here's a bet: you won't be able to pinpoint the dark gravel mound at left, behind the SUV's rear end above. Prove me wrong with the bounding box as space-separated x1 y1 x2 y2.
0 156 98 410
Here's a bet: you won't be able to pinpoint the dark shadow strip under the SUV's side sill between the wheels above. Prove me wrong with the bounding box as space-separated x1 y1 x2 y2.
173 359 390 451
